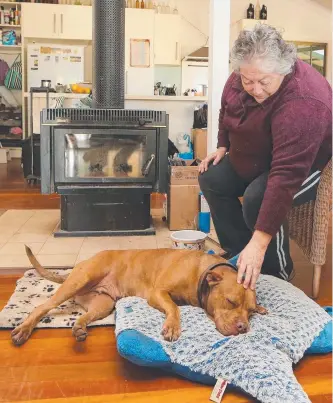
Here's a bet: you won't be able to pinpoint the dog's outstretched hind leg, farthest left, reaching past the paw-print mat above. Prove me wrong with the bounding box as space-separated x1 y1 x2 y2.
11 261 98 346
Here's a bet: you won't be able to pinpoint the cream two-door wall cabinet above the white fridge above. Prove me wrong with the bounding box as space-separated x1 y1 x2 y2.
22 3 92 40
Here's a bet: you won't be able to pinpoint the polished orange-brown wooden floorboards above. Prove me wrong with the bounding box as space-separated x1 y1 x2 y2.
0 159 332 403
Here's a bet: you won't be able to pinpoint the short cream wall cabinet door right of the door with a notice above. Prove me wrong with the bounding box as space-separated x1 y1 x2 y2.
154 14 181 66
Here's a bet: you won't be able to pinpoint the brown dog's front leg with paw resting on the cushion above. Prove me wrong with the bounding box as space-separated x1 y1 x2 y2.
148 291 181 341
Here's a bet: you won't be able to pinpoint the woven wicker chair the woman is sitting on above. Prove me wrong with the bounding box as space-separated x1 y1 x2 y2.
288 160 332 299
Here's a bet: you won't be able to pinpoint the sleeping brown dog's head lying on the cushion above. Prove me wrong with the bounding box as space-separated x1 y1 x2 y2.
201 267 267 336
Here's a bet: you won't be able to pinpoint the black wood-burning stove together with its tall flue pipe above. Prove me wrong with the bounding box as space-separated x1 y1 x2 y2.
41 0 169 236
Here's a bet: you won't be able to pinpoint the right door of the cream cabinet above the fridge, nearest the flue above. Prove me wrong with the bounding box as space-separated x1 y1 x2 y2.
57 6 92 41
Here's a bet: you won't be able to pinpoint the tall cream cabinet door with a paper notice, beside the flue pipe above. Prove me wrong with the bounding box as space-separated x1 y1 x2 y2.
125 8 155 95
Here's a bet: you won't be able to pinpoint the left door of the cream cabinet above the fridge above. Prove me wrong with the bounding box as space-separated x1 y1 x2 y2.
21 3 60 38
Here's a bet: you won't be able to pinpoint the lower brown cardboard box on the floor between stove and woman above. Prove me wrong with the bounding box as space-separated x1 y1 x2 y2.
167 185 200 230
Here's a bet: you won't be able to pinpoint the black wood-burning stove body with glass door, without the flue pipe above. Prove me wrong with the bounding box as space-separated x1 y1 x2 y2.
41 109 168 236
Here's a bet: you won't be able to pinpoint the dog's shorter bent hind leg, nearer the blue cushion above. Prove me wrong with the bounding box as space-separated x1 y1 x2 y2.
72 292 115 341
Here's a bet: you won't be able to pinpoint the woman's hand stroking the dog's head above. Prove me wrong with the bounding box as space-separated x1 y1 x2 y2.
237 231 272 290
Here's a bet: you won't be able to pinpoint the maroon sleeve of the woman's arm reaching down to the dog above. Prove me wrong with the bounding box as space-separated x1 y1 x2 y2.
255 99 332 236
